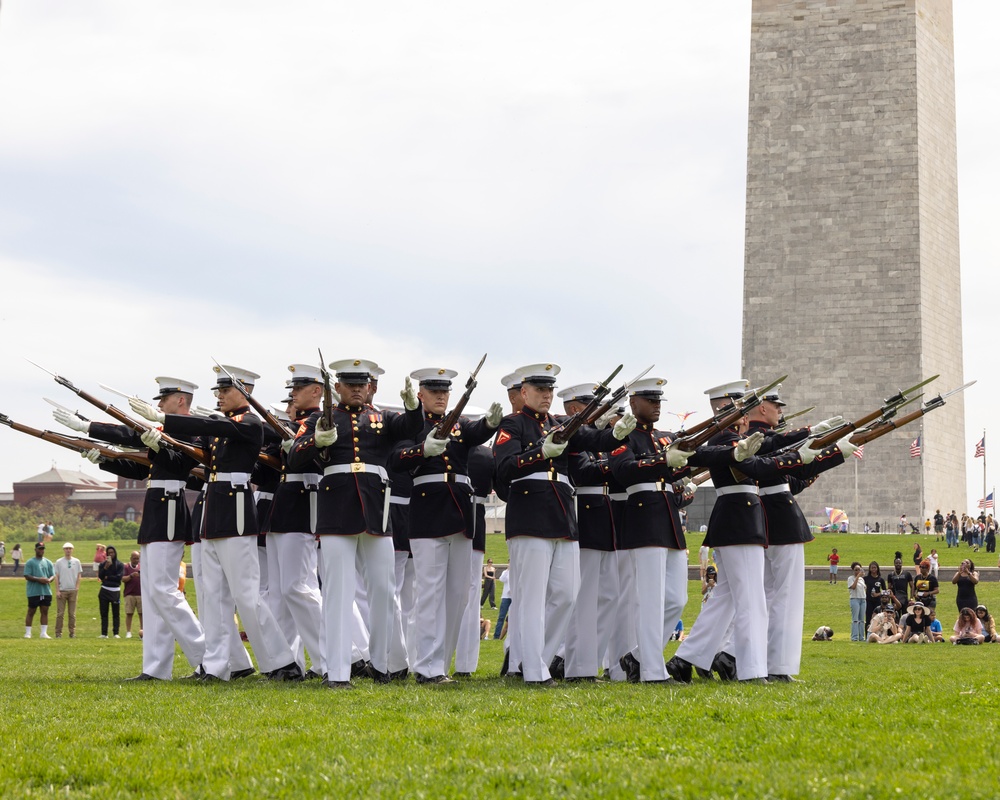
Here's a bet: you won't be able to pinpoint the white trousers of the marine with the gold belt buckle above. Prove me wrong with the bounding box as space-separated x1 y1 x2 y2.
321 533 395 681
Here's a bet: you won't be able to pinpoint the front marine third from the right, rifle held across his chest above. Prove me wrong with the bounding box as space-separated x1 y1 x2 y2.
611 378 694 683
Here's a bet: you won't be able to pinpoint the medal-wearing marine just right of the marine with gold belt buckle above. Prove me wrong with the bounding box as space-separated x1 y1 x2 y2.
390 367 503 686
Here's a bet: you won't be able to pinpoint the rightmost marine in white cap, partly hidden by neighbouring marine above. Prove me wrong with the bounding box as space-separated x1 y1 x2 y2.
747 384 846 683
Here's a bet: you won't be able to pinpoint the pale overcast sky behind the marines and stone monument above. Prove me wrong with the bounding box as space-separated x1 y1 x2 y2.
0 0 1000 507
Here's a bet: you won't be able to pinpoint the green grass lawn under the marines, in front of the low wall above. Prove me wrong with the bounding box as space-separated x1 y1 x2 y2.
0 564 1000 800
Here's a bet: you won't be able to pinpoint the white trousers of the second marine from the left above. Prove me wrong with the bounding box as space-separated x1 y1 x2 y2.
201 536 294 679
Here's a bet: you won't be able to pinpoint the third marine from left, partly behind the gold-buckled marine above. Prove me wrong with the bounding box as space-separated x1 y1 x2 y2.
265 364 326 677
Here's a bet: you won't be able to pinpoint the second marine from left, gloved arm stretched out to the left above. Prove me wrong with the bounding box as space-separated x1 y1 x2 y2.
129 366 303 681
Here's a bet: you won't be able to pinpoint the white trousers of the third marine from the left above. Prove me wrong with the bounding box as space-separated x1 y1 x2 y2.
265 532 326 675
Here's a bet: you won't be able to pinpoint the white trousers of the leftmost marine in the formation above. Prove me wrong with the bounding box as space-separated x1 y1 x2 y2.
139 542 205 681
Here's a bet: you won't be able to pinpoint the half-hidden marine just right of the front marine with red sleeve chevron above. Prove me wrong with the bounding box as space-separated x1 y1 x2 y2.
549 383 625 682
